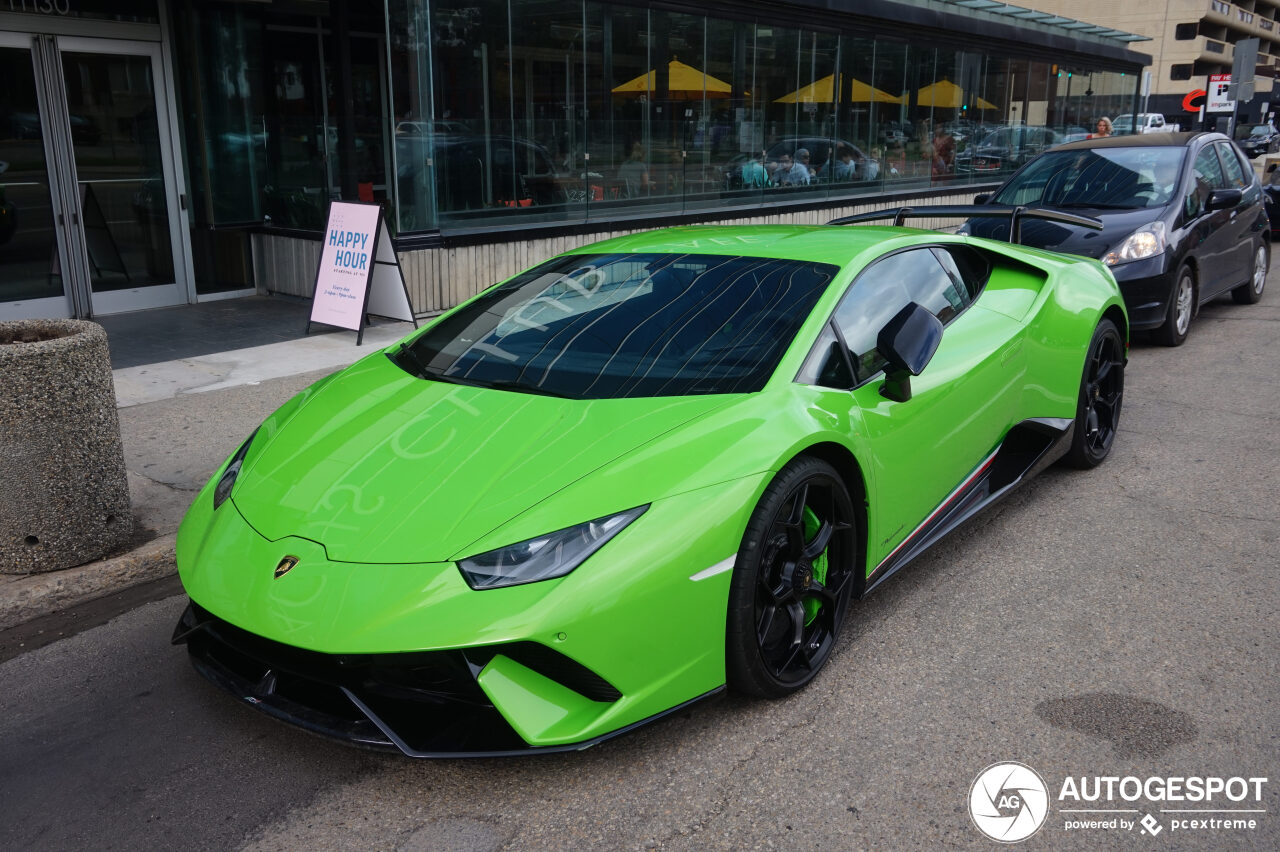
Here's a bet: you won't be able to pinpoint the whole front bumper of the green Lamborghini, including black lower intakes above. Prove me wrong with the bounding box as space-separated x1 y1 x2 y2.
174 475 764 756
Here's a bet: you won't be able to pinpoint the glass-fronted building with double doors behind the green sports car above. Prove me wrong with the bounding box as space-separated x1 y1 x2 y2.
0 0 1148 319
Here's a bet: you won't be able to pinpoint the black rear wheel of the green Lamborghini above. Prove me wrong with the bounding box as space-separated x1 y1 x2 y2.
1068 320 1125 469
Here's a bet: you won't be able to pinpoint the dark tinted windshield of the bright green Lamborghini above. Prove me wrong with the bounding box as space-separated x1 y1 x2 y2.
393 255 838 399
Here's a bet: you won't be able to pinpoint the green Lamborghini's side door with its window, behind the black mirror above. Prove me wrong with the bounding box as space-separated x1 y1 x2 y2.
835 247 1021 568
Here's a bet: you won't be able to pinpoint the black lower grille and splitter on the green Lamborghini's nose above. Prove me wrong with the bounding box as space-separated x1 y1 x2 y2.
173 593 723 757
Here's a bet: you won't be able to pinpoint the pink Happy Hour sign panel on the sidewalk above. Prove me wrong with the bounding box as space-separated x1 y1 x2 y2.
311 201 379 331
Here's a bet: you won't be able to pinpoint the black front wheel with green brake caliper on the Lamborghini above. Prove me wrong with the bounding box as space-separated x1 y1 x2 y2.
724 457 858 697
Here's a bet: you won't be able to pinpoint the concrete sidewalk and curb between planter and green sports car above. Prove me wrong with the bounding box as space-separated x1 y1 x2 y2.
0 297 412 631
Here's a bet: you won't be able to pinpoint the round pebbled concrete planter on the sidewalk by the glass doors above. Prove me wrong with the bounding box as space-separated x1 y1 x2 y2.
0 320 133 574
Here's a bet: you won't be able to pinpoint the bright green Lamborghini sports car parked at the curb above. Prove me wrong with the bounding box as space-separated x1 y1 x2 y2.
174 212 1128 757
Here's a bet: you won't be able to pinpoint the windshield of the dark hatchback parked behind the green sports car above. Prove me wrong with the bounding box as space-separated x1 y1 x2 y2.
992 147 1184 210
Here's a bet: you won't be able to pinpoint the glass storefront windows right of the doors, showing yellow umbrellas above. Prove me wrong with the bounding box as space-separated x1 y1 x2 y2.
177 0 1138 234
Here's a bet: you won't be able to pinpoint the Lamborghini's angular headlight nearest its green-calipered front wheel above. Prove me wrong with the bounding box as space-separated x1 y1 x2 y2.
458 505 649 588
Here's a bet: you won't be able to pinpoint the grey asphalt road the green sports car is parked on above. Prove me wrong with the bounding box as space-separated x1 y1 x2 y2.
0 275 1280 851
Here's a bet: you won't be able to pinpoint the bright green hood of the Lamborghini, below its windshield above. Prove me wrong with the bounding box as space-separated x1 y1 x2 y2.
232 356 733 563
